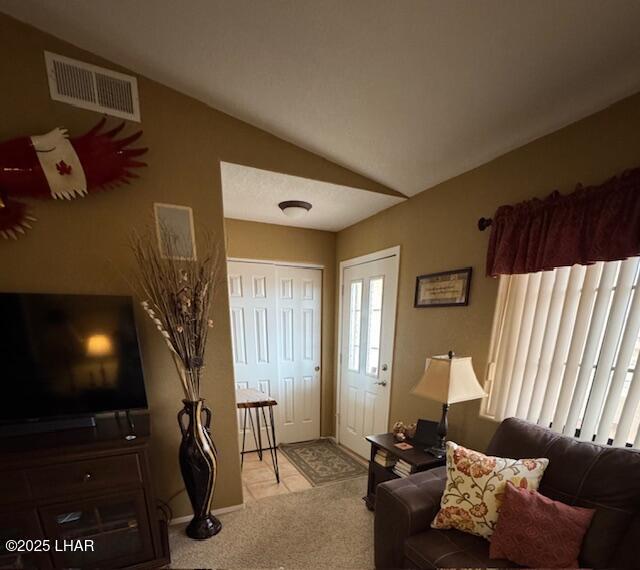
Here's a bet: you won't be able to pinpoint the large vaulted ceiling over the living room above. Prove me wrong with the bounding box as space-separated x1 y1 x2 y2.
0 0 640 194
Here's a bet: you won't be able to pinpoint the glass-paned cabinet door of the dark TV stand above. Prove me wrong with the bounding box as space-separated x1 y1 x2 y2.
41 490 153 568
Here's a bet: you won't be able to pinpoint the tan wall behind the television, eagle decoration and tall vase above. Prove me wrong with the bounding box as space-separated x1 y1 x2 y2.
0 15 388 516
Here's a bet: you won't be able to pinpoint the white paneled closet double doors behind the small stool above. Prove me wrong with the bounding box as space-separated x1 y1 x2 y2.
227 261 322 449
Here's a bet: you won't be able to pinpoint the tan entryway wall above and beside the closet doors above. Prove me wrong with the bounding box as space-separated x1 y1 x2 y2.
224 218 336 436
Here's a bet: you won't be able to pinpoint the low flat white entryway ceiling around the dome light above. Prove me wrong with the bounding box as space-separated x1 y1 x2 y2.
220 162 404 232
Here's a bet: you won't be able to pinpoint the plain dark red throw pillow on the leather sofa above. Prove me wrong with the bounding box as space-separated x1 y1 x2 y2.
489 482 595 568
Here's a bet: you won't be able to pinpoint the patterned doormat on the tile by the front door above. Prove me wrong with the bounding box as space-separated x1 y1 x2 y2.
280 439 367 487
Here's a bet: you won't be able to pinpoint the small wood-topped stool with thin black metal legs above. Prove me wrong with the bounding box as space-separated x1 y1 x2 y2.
236 388 280 483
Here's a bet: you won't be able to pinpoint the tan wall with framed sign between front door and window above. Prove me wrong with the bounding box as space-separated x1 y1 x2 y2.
337 91 640 449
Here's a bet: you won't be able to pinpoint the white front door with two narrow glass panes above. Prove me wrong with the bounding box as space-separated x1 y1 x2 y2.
338 254 398 457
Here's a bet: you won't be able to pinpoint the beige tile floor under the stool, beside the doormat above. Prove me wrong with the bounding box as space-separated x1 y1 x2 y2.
242 446 311 503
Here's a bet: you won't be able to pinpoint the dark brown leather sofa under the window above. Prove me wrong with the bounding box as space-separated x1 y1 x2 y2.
375 418 640 569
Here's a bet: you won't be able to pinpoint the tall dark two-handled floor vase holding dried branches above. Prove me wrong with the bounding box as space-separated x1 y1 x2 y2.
178 399 222 540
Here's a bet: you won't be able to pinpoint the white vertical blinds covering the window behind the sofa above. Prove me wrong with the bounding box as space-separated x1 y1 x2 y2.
482 257 640 447
